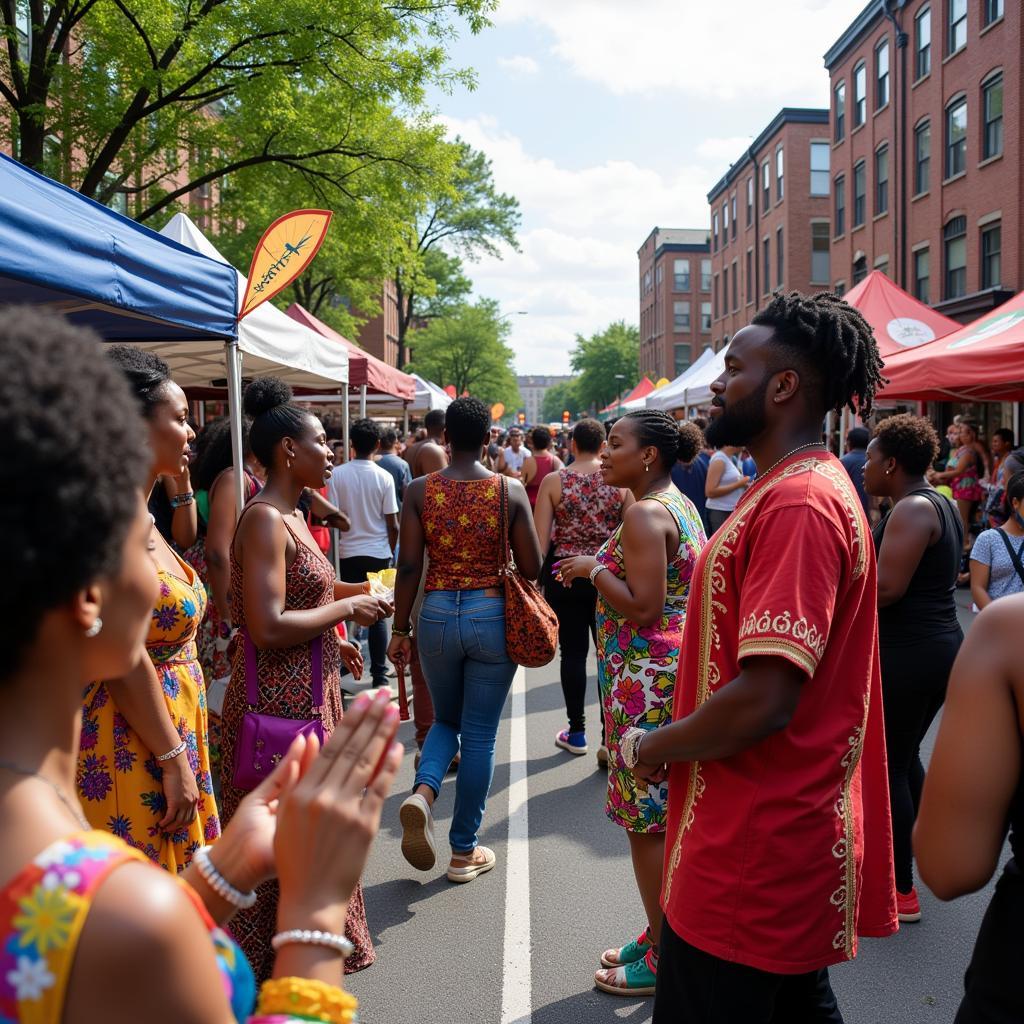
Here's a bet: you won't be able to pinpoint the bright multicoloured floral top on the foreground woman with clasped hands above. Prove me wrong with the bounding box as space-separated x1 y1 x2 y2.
0 831 256 1024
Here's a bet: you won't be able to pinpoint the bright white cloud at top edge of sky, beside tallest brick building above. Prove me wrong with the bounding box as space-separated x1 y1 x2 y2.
495 0 859 105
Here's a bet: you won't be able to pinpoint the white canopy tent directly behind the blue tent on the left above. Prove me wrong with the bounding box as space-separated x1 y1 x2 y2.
138 213 348 511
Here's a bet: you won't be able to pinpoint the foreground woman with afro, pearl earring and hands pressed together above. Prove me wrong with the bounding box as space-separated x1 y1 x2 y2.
0 307 401 1024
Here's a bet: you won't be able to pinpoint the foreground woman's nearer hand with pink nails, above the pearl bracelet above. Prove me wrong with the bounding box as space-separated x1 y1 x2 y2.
273 689 402 933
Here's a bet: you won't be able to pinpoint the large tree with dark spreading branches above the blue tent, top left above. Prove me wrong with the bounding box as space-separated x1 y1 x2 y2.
0 0 496 220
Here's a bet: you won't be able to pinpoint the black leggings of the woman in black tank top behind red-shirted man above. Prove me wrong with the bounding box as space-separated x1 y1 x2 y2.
881 627 964 893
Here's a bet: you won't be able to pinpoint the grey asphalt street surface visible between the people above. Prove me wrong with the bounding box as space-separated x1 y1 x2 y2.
347 593 991 1024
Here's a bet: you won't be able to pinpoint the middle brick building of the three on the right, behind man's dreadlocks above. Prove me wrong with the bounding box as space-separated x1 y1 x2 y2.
707 106 831 349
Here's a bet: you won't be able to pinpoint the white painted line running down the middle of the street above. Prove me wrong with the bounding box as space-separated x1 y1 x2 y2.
502 667 532 1024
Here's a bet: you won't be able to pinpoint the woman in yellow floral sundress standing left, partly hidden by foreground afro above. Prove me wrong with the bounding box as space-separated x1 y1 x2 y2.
78 345 220 872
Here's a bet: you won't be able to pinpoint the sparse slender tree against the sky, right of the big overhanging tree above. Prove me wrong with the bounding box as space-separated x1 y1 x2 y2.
394 139 520 366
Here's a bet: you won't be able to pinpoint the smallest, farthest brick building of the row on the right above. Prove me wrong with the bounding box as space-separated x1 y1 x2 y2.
637 227 712 381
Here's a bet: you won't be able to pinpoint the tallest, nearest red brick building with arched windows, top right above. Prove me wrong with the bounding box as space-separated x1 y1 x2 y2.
824 0 1024 323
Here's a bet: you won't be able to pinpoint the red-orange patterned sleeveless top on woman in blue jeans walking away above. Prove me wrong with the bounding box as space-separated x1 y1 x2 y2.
422 473 505 591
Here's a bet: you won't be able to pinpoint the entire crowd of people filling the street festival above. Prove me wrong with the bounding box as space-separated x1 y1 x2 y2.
0 293 1024 1024
